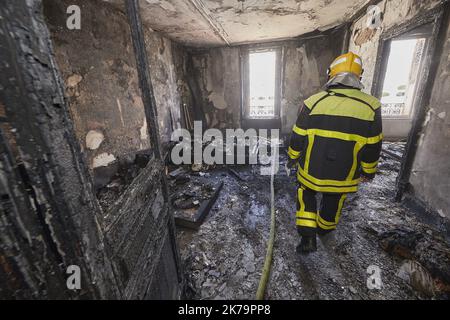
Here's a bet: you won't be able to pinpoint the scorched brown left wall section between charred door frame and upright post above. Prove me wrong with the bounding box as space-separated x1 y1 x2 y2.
44 0 150 169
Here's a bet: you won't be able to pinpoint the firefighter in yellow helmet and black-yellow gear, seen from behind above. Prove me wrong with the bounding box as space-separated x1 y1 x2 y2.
288 52 383 254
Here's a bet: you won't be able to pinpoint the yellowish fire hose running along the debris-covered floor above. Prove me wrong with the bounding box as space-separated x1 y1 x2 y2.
256 165 275 300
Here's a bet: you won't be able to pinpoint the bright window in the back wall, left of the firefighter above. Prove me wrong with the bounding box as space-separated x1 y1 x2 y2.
243 48 281 120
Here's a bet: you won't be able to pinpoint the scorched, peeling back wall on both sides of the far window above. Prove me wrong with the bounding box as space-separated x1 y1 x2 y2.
183 29 344 133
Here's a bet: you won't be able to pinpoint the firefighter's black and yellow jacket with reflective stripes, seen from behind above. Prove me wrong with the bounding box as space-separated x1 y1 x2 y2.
288 87 383 193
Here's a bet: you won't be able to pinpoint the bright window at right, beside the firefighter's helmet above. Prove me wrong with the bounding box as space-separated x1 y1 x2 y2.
381 38 426 117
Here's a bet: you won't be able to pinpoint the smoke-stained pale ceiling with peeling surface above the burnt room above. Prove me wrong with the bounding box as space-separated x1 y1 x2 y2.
110 0 369 46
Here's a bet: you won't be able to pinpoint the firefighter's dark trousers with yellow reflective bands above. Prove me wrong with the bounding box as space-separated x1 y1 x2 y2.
296 186 347 236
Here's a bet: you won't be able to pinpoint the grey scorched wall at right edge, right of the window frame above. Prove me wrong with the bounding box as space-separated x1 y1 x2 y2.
410 10 450 219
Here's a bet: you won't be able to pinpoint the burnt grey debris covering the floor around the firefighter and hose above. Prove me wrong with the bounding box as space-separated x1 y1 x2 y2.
174 144 450 299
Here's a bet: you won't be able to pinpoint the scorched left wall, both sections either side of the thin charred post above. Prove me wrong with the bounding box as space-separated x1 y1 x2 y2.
44 0 182 185
